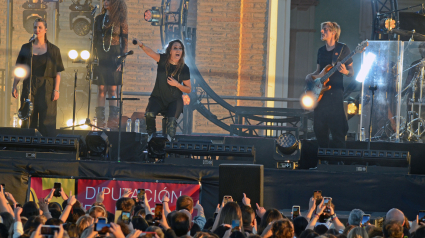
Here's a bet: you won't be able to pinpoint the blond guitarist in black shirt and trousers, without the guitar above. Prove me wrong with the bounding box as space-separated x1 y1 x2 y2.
306 21 354 148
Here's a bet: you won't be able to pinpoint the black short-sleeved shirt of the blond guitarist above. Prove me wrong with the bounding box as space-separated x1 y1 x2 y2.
317 42 353 91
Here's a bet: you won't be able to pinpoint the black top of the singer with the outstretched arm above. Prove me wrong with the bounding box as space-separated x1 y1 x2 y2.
151 54 190 104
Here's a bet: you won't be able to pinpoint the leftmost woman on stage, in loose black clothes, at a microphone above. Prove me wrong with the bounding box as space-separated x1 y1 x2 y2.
12 18 65 136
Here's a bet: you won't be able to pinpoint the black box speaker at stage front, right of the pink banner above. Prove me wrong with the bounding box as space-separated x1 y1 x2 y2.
218 164 264 208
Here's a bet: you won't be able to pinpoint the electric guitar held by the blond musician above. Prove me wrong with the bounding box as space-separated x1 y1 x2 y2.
305 40 369 102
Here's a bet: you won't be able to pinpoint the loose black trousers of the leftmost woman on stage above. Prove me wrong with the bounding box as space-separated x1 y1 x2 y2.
21 77 57 137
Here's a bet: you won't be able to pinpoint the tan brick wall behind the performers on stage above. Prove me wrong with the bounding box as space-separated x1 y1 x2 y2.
0 0 267 133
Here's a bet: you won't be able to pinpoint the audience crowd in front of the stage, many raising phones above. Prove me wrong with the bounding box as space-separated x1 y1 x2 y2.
0 186 425 238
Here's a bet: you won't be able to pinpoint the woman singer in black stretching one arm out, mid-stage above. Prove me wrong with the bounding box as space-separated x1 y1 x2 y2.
134 40 192 141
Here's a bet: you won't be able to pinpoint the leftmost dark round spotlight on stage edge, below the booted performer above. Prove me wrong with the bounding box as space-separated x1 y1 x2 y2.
86 131 109 159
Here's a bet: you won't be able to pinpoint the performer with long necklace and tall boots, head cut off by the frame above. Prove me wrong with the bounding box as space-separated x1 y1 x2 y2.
93 0 128 129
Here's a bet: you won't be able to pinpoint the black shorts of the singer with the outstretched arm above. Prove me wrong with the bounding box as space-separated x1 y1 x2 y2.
146 96 184 119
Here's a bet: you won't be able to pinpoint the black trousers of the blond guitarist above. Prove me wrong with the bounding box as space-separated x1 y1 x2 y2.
314 90 348 148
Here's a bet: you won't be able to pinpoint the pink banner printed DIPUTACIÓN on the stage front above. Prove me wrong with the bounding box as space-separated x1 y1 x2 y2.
77 179 200 213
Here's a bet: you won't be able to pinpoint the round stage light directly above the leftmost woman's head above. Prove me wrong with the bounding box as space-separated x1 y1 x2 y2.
22 0 47 34
